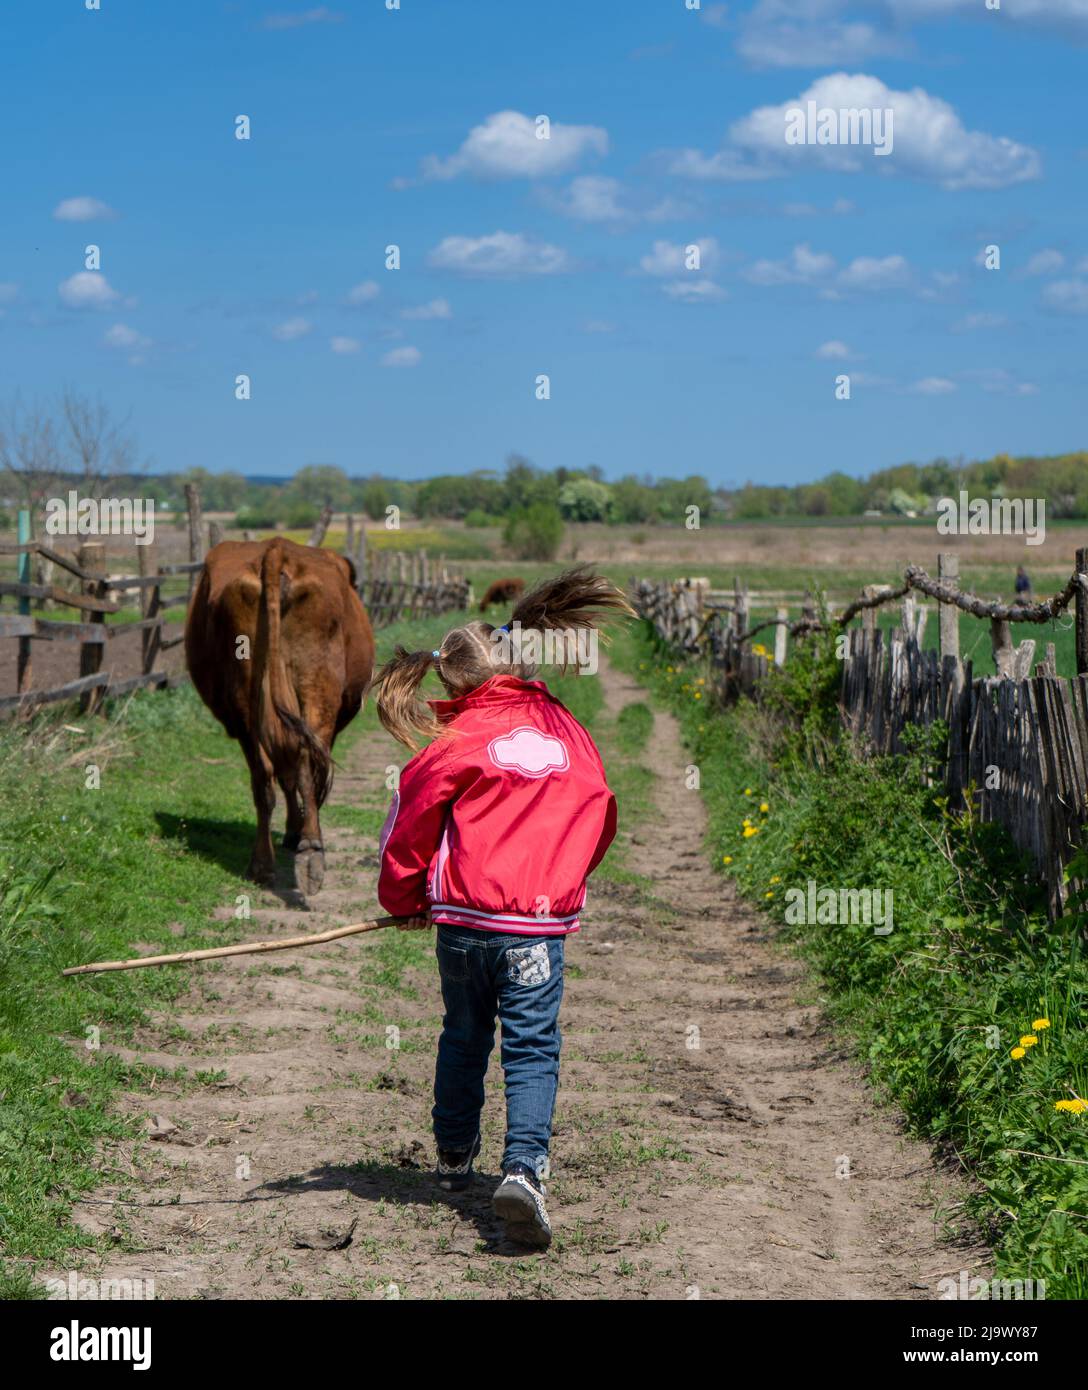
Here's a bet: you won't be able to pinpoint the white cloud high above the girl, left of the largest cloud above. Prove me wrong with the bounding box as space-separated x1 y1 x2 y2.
414 111 609 182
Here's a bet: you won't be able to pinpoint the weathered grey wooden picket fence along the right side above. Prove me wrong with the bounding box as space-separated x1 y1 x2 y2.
631 550 1088 916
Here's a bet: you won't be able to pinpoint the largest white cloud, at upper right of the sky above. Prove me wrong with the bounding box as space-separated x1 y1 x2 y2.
668 72 1041 190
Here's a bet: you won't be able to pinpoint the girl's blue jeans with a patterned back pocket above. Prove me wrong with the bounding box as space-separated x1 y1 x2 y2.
431 926 563 1175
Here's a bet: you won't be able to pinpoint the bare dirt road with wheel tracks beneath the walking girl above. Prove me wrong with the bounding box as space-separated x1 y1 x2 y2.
61 656 985 1300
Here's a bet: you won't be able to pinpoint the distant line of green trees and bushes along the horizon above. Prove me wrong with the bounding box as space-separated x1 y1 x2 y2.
0 388 1088 549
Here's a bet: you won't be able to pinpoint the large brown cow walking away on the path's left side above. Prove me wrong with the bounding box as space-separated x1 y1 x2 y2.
185 537 374 894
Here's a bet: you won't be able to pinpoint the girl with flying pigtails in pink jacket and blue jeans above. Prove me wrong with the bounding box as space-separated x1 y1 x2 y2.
377 569 634 1248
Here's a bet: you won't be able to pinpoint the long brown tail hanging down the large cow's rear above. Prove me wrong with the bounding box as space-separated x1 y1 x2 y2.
254 541 332 806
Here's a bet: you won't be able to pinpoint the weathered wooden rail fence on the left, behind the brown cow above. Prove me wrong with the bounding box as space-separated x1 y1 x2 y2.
0 497 471 713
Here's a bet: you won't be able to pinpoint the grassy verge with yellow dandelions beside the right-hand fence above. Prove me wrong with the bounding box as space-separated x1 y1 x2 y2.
614 628 1088 1298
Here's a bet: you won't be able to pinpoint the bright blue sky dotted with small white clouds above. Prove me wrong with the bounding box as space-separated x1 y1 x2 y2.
0 0 1088 485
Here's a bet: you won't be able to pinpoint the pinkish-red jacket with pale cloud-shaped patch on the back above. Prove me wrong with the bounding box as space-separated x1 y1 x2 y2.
378 676 616 935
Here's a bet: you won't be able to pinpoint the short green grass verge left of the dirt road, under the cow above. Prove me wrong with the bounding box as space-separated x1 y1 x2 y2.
0 616 469 1297
